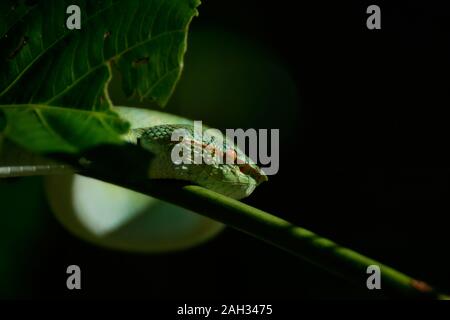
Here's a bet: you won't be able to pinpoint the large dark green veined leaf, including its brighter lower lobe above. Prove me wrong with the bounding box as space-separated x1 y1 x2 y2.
0 0 199 152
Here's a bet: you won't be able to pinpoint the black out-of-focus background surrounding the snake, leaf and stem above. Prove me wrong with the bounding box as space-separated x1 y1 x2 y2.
0 0 450 301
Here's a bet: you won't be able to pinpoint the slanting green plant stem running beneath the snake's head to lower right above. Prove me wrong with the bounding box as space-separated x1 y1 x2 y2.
91 174 446 299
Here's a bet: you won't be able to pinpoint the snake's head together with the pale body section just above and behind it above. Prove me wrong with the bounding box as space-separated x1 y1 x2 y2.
116 107 267 199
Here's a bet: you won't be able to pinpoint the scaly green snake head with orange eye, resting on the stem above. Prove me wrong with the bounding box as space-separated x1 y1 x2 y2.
133 124 267 199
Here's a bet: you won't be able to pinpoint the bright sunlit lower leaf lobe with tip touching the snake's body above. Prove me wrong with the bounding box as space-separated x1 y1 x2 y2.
1 104 128 153
